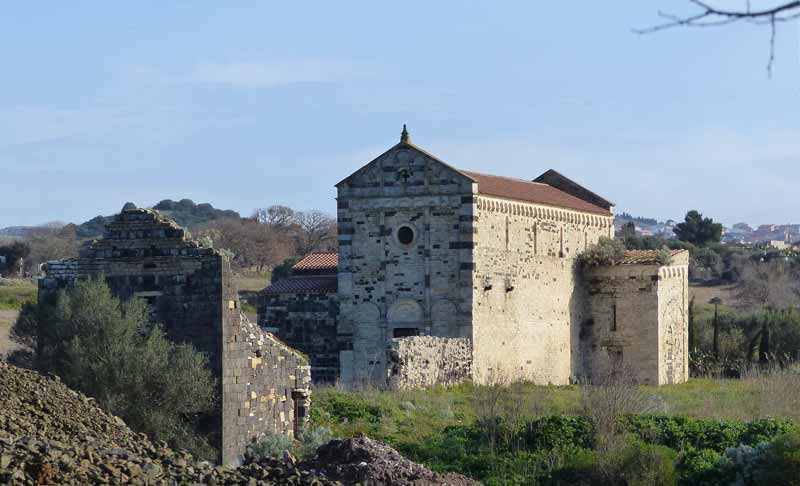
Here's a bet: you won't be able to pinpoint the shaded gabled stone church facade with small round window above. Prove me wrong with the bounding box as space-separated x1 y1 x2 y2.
338 145 473 384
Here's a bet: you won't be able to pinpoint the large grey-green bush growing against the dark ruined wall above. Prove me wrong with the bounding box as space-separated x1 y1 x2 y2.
12 279 219 460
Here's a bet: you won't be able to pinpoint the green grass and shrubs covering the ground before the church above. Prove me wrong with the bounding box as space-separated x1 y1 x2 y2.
312 368 800 486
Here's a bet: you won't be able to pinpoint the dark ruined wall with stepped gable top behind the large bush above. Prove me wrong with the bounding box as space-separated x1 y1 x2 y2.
39 209 228 374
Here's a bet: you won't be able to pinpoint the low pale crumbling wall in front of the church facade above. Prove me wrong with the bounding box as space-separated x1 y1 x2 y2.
386 336 472 390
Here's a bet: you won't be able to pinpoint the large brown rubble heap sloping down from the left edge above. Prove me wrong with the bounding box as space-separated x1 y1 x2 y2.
0 361 340 486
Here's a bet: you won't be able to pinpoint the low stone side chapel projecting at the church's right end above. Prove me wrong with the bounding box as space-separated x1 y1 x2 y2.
581 254 689 385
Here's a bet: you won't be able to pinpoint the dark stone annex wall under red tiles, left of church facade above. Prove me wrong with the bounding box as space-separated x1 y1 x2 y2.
258 292 340 384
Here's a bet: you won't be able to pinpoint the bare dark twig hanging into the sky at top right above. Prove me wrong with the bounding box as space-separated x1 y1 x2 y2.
633 0 800 75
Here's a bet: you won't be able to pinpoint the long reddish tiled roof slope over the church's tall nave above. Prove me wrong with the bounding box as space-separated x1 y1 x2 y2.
461 171 611 215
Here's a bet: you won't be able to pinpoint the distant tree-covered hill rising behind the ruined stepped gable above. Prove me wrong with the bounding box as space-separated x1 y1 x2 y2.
75 199 241 238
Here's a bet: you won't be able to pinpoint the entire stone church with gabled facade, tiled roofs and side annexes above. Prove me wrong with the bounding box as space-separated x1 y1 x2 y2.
259 127 688 387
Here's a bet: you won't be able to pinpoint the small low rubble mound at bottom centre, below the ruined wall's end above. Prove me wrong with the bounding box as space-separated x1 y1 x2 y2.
301 436 479 486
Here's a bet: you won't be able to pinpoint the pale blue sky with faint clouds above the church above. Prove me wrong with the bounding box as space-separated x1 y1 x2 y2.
0 0 800 227
